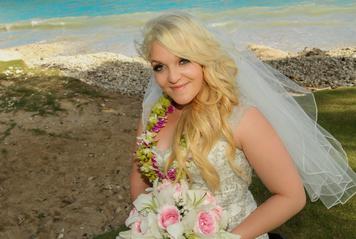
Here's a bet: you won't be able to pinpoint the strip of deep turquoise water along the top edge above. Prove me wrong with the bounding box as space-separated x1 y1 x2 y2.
0 0 354 23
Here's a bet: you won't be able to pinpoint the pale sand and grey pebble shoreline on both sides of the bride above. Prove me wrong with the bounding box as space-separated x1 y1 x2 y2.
0 41 356 96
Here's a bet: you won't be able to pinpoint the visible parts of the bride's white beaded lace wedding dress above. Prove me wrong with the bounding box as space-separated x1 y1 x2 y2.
154 102 268 239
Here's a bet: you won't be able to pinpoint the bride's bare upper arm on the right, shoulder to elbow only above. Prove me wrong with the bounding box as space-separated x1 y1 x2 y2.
236 107 305 204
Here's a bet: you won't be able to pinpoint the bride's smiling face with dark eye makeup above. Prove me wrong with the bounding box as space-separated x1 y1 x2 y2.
150 42 204 106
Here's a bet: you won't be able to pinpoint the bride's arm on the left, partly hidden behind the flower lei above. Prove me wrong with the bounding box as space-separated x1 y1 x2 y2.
130 118 150 201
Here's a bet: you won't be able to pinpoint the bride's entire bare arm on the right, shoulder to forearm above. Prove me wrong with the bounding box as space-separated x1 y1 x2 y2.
232 107 306 239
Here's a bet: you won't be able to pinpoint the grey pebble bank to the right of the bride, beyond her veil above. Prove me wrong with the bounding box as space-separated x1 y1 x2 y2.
265 45 356 90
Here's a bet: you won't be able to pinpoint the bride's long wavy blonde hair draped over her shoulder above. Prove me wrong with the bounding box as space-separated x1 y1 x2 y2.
137 12 247 191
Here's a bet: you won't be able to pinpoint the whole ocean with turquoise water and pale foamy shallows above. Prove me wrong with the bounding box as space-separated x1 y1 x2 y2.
0 0 356 56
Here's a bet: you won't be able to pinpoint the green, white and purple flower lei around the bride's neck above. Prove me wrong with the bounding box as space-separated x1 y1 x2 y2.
136 96 181 182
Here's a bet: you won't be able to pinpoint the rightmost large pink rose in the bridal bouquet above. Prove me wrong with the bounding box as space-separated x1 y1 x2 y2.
194 211 218 236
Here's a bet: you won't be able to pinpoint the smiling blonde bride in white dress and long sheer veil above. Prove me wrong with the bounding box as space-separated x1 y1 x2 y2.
131 12 355 239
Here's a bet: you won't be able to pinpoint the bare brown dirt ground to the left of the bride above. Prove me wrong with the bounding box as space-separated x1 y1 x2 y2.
0 66 140 239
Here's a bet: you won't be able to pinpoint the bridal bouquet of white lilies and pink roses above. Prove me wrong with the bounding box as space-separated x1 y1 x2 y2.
116 180 240 239
